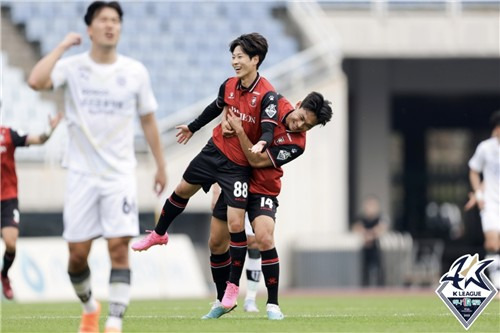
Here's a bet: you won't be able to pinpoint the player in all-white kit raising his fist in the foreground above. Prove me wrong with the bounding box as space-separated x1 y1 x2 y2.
28 1 167 332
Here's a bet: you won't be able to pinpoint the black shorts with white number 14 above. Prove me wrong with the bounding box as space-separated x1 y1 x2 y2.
212 193 279 222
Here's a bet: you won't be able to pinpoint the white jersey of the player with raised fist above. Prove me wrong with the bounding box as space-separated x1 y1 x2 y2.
51 53 158 176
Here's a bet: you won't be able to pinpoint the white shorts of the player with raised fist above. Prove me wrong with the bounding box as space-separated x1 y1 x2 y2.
63 170 139 242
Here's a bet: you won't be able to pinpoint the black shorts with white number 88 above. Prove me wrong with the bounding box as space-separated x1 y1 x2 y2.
182 139 252 209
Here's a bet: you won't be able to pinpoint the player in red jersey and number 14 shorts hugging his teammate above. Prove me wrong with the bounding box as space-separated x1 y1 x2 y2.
203 92 332 320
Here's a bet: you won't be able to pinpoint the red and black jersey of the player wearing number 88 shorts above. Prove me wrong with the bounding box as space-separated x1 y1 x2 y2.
212 75 278 166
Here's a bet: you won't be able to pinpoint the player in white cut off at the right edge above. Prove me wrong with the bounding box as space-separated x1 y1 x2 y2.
466 110 500 288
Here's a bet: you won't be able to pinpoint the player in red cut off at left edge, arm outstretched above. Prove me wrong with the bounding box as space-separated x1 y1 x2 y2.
0 113 62 299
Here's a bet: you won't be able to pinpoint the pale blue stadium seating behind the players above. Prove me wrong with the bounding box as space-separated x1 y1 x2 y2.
4 1 299 118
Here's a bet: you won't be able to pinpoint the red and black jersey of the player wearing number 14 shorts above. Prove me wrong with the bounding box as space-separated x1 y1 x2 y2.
250 96 306 196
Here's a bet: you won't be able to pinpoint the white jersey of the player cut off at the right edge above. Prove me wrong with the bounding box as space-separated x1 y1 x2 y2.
469 138 500 210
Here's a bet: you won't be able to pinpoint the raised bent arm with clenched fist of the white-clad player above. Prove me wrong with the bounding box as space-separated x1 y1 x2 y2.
28 32 82 90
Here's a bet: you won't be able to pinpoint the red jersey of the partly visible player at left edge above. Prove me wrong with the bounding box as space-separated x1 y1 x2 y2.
0 126 28 200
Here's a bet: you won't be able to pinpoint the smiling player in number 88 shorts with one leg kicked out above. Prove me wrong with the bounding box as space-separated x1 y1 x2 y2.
132 33 278 311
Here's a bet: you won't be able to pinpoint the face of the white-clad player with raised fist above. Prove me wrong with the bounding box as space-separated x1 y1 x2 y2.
87 7 122 47
